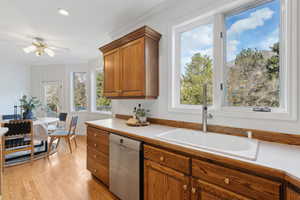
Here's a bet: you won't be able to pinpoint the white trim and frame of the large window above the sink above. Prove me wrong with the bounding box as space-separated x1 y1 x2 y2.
168 0 299 120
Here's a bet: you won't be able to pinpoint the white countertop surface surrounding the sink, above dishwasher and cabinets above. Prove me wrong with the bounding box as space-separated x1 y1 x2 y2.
86 118 300 180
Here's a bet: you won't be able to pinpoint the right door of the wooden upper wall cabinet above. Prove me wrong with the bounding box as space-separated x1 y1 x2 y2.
120 38 145 97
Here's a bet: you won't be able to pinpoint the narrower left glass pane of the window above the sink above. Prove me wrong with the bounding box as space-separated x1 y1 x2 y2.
180 24 213 105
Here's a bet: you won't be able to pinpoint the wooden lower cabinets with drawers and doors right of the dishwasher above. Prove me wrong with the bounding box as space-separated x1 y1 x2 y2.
144 145 282 200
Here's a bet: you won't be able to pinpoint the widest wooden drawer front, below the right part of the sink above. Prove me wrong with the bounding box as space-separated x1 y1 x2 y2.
192 159 281 200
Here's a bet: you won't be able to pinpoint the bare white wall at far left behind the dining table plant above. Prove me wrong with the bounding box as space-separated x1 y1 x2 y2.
0 62 30 115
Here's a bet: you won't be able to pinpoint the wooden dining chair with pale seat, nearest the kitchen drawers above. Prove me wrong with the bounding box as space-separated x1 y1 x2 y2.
48 116 78 156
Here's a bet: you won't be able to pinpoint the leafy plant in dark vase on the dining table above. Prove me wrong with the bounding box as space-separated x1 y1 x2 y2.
20 95 41 119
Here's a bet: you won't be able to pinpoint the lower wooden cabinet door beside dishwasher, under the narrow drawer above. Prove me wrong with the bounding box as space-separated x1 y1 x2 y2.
144 160 190 200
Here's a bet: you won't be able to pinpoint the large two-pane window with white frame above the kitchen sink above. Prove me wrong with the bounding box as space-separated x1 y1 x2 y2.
169 0 297 118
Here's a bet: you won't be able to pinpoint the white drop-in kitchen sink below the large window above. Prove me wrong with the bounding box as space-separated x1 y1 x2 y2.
157 129 259 160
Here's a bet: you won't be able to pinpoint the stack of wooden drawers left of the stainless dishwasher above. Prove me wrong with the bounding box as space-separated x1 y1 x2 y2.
87 127 109 186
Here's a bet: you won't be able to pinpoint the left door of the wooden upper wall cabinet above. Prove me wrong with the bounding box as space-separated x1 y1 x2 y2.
103 49 121 97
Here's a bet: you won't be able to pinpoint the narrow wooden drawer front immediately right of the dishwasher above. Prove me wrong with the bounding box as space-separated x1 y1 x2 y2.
144 145 190 174
